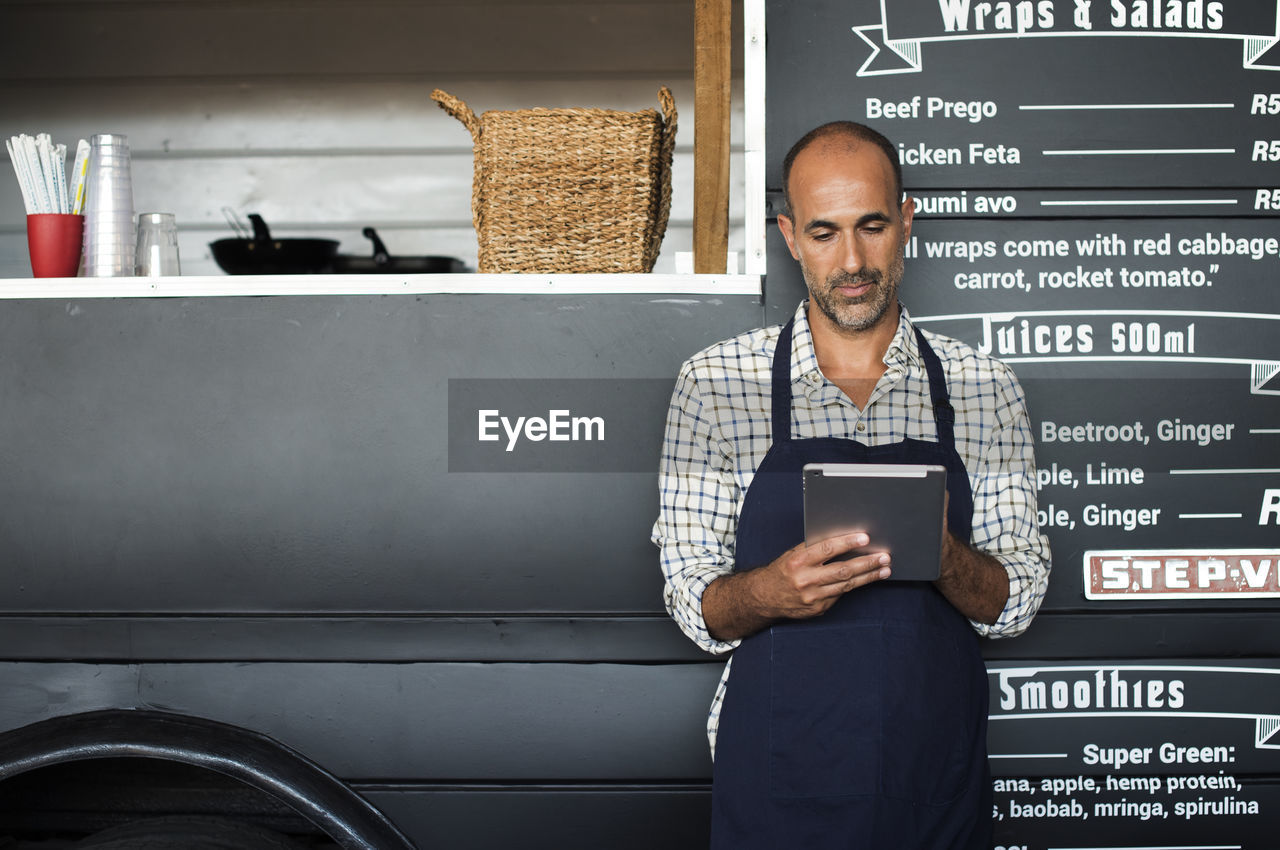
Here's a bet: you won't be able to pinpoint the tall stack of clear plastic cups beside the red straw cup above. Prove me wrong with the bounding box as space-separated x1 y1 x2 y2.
82 133 137 278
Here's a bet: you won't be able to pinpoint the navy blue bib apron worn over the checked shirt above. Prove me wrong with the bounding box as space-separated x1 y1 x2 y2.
712 323 992 850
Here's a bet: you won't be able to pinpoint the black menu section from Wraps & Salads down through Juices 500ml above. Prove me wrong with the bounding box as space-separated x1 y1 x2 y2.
767 0 1280 612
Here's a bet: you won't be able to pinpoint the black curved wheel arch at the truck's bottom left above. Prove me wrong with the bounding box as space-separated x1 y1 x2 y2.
0 709 416 850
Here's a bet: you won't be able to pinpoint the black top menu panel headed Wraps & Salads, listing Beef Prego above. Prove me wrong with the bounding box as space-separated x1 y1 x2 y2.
767 0 1280 190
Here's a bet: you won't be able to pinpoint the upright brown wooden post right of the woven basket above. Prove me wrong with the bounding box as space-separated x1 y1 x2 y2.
694 0 733 274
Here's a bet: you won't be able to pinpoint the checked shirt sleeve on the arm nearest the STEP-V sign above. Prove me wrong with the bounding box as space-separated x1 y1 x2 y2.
970 362 1051 638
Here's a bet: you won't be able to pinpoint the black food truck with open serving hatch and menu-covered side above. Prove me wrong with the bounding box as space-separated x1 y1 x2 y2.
0 0 1280 849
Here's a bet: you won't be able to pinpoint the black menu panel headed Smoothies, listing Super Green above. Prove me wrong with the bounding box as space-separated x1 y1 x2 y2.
988 663 1280 850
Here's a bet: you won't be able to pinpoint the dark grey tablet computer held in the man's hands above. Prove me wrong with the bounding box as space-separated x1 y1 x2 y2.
804 463 947 581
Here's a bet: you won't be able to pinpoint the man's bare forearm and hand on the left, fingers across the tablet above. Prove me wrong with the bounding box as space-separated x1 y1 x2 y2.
703 531 890 640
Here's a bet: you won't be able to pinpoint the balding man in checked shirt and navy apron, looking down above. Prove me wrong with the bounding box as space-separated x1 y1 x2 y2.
653 122 1050 850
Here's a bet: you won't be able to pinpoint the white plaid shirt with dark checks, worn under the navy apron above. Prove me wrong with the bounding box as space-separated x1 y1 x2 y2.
653 302 1050 755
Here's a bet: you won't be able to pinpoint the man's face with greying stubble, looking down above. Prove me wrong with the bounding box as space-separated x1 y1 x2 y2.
778 136 914 333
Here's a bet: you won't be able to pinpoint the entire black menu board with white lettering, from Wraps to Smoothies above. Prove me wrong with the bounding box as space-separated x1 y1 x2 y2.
765 0 1280 850
